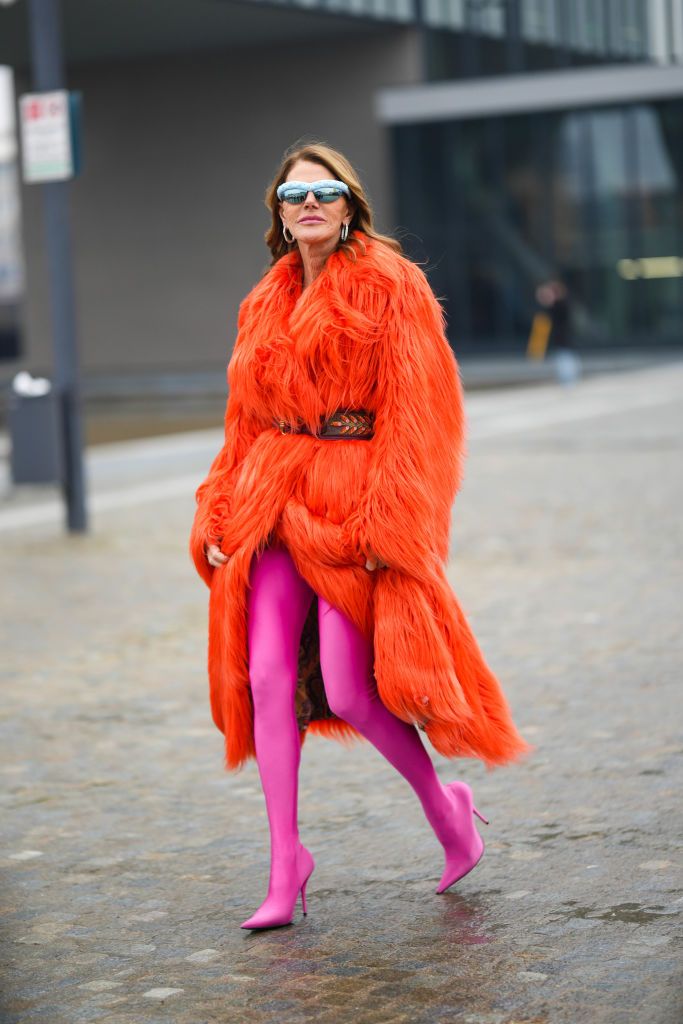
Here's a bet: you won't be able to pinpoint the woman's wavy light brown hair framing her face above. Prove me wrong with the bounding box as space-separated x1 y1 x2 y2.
264 141 402 265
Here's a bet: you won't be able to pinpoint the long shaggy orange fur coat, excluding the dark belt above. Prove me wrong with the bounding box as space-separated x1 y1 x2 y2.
190 231 529 769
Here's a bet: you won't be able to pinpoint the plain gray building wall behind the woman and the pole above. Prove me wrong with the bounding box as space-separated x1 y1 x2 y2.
16 29 420 385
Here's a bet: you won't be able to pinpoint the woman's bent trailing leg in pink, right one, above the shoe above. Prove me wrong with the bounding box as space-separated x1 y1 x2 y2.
318 597 466 844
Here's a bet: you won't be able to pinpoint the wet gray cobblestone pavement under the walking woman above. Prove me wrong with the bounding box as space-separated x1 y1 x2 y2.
0 364 683 1024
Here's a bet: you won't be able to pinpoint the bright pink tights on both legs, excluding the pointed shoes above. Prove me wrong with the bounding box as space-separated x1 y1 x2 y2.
248 548 455 859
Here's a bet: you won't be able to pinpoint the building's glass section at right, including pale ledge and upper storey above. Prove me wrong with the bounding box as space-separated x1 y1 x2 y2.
385 0 683 354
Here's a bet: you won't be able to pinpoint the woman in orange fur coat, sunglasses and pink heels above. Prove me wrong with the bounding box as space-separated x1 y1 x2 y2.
190 144 529 929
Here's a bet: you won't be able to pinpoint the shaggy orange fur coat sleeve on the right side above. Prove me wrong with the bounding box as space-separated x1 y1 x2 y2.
345 260 465 579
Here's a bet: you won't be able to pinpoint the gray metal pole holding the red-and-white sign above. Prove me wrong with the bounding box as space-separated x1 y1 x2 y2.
29 0 87 532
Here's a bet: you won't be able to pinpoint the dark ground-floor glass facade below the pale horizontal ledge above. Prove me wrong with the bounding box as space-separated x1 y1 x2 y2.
393 100 683 351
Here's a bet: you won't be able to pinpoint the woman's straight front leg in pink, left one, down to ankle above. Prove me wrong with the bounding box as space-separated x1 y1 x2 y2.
247 548 313 909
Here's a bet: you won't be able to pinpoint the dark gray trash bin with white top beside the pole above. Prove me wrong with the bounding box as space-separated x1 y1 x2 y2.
8 371 61 483
